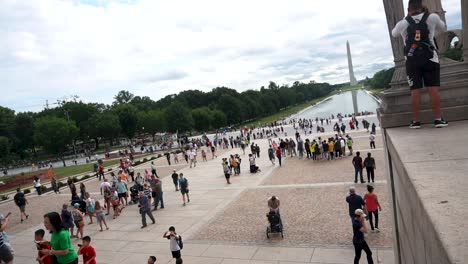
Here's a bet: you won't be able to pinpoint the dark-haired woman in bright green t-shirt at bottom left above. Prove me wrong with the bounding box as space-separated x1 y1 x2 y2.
41 212 78 264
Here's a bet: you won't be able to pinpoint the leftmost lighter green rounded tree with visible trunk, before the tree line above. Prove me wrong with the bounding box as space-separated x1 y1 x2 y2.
34 116 78 166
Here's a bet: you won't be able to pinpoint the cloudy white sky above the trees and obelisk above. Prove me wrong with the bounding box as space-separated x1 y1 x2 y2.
0 0 461 111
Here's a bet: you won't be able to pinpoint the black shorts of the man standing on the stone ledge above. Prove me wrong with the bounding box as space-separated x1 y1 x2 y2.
406 60 440 90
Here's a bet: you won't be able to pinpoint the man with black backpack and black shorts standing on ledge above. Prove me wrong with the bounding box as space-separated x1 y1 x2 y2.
392 0 448 128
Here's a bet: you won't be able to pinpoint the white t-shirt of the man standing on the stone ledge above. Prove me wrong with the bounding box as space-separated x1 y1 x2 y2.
392 13 447 63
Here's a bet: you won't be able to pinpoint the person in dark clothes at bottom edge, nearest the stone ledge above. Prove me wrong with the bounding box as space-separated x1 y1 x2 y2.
353 209 374 264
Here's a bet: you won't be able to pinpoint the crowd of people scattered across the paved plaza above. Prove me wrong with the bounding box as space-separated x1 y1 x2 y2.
0 112 379 263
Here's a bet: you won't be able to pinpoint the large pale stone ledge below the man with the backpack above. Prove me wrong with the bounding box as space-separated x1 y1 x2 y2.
385 121 468 263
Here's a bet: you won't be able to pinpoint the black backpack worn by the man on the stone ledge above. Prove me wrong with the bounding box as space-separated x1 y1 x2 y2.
405 13 435 63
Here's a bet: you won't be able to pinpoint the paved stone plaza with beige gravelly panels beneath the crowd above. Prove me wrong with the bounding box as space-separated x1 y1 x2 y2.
0 120 394 264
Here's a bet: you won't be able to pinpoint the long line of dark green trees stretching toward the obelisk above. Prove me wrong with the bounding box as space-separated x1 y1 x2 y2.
0 81 336 167
